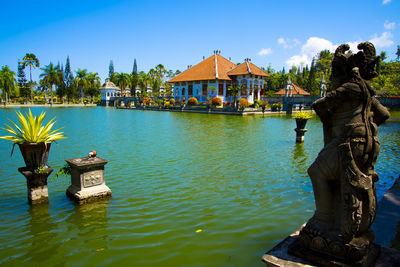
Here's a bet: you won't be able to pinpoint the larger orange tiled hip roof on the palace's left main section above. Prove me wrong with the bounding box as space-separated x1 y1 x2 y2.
168 54 236 83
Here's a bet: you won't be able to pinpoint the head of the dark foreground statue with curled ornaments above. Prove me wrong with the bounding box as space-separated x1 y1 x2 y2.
331 42 379 90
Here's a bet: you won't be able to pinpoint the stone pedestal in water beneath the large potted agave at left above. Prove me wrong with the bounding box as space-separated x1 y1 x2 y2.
18 166 53 204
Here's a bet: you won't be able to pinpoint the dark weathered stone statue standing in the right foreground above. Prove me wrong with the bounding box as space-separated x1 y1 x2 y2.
299 42 389 265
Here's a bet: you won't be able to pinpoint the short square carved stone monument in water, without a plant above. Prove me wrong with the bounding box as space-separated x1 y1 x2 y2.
66 151 111 204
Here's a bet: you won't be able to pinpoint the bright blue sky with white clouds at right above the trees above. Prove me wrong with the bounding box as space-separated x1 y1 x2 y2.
0 0 400 81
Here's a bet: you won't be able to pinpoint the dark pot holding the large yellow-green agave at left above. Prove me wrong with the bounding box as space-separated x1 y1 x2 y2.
18 142 51 168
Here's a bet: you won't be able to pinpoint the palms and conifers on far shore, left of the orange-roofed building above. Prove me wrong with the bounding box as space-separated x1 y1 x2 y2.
0 53 180 104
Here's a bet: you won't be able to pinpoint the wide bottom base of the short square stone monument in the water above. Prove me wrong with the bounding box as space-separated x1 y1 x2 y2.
66 184 111 205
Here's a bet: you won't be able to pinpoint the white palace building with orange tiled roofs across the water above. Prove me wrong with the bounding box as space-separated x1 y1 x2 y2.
168 50 270 103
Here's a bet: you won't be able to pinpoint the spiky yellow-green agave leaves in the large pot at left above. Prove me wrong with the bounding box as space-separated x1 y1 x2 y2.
0 109 66 144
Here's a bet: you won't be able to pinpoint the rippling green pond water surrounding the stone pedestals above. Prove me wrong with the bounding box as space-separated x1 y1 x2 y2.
0 107 400 266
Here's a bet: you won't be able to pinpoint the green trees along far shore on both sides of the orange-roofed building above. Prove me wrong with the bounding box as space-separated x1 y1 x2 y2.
0 45 400 103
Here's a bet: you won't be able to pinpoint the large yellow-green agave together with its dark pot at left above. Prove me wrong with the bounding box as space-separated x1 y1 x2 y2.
0 109 66 169
